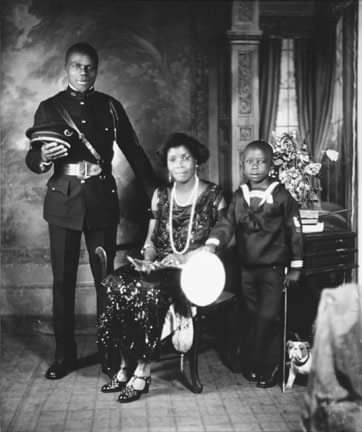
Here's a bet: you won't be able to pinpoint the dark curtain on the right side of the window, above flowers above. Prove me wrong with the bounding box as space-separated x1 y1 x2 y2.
294 23 336 160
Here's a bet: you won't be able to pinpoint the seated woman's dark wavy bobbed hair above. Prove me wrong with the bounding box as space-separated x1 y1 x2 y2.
157 132 209 166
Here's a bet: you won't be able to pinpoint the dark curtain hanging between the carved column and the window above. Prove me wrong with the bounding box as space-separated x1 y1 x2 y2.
259 38 282 141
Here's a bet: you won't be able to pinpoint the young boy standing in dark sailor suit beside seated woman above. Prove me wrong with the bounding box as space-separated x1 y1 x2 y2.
206 141 303 388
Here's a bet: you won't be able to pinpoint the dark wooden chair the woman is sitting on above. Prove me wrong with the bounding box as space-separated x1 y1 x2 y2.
95 243 236 393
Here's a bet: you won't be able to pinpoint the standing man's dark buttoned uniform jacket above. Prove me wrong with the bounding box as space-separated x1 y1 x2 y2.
26 87 156 230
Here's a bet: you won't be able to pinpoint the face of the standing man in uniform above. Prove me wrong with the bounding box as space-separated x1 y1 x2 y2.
65 52 97 93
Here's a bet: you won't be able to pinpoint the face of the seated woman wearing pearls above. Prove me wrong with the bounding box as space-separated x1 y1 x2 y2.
167 146 196 183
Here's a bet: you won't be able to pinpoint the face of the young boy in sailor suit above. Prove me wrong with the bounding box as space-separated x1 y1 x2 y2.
243 148 271 183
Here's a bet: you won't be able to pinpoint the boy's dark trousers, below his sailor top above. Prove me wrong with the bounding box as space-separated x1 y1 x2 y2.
241 266 285 373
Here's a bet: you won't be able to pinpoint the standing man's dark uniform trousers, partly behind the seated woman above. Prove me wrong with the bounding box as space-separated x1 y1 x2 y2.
49 225 117 362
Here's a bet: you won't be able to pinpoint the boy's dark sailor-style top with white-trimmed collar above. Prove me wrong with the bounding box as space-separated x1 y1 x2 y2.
210 184 303 268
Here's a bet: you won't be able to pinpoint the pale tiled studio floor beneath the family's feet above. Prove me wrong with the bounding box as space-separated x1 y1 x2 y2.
0 334 305 432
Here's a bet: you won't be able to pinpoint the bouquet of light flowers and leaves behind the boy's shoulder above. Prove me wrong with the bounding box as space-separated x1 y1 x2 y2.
271 133 321 208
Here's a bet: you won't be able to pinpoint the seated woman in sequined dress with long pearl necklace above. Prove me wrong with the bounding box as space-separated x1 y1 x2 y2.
98 133 225 403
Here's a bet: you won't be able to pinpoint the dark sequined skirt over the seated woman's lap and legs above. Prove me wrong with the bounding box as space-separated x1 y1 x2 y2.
98 266 190 361
